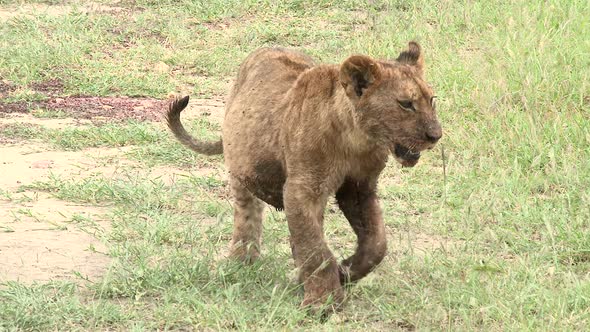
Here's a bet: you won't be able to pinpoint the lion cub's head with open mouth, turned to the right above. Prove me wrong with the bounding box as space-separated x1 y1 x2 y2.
340 42 442 167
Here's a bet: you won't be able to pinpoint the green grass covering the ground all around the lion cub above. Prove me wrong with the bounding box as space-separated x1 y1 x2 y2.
0 0 590 331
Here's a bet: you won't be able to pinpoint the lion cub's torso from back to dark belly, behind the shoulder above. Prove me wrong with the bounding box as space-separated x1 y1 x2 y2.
222 48 313 208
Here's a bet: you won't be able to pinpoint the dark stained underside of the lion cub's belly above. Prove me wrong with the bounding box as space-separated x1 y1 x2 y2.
238 160 286 210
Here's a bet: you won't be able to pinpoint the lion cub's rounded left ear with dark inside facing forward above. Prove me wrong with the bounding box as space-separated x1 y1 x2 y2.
340 55 381 98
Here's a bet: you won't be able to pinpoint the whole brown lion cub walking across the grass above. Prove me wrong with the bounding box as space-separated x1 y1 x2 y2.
168 42 442 314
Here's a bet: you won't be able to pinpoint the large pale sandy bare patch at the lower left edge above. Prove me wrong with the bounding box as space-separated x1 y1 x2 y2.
0 196 110 283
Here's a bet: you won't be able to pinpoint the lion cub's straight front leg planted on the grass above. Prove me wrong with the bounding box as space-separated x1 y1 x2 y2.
283 178 344 311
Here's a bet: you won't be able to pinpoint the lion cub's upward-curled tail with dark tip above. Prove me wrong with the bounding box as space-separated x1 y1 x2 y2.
166 96 223 156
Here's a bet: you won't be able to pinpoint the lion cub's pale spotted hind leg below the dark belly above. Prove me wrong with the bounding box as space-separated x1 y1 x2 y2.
230 178 264 263
